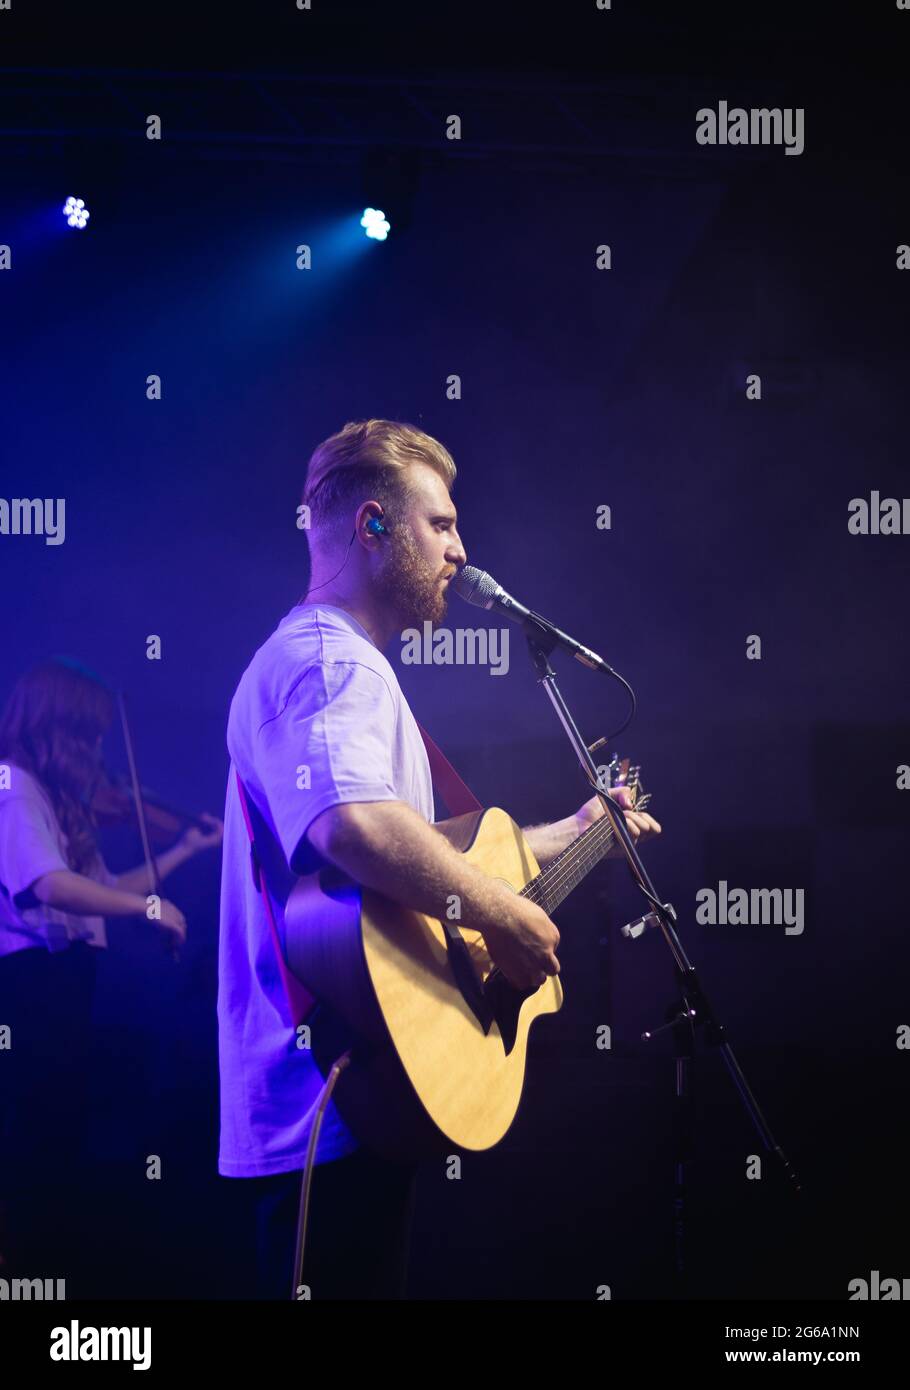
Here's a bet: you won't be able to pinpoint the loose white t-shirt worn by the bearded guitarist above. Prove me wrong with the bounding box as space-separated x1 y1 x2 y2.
218 605 433 1177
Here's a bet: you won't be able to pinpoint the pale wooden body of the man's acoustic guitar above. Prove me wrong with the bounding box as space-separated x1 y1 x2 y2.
285 808 563 1159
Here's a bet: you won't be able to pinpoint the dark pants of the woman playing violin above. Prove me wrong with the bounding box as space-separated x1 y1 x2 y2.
0 941 99 1277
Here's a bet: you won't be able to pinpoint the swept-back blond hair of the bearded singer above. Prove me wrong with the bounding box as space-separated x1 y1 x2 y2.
303 420 456 525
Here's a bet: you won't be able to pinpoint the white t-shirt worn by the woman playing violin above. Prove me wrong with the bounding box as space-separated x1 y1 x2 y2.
0 763 117 956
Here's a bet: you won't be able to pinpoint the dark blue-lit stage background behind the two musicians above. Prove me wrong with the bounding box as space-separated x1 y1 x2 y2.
0 3 910 1298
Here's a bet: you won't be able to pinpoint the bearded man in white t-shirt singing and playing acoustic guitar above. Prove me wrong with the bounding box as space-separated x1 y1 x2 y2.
218 420 660 1298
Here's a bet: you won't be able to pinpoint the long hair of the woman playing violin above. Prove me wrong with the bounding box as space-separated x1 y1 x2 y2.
0 657 114 873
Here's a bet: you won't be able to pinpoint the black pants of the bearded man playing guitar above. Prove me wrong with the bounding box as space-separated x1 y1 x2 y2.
245 1148 417 1301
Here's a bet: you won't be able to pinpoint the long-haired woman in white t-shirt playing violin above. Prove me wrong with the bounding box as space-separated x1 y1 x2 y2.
0 660 222 1277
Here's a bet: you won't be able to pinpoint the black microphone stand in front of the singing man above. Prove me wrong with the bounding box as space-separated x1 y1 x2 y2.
521 625 802 1293
